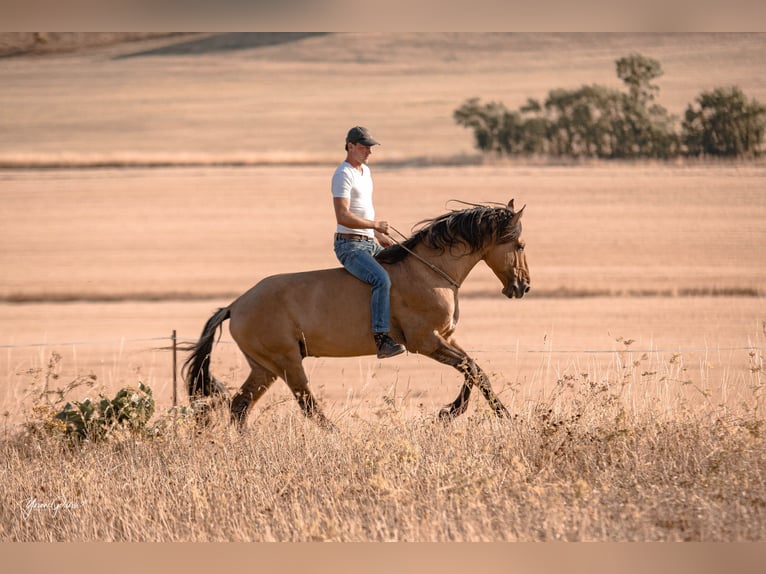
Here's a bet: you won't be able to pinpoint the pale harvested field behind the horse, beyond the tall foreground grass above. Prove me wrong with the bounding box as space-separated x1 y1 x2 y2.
0 34 766 424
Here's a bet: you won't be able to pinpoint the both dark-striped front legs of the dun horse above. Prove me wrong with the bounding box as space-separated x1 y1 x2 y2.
429 341 511 419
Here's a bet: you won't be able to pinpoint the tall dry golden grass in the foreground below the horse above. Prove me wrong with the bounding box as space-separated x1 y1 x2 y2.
0 341 766 541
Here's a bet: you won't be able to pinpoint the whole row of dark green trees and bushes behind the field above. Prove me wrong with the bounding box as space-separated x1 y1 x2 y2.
453 54 766 159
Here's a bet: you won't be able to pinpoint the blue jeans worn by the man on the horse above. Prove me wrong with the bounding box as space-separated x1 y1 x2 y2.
333 239 391 333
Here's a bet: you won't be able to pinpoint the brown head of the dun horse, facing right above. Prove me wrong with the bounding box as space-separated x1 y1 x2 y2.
484 200 530 298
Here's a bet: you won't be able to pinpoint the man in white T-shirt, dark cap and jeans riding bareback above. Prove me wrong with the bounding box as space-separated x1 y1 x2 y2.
332 126 405 359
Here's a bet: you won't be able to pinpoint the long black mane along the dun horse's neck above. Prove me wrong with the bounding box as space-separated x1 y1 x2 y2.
376 202 521 263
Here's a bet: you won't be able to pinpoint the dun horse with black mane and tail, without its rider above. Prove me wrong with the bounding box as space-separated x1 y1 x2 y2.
184 200 530 426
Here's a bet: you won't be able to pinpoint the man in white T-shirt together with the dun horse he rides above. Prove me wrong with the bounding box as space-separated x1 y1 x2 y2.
184 126 530 427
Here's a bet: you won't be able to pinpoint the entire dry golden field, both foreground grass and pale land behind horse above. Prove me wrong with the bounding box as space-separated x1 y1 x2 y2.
0 34 766 541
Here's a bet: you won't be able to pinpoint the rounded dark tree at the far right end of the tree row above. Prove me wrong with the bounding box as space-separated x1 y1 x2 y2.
681 86 766 157
